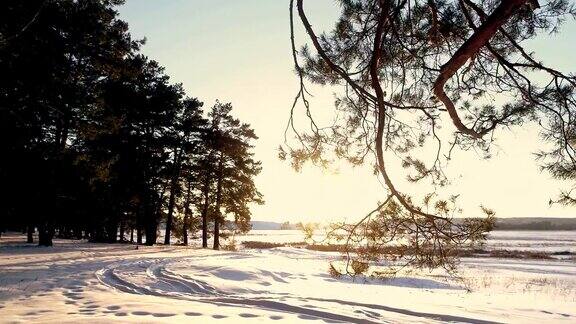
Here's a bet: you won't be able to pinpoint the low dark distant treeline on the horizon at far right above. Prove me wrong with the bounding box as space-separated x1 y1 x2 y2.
494 217 576 231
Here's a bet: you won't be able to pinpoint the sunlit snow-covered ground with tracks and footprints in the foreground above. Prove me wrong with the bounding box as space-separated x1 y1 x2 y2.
0 235 576 323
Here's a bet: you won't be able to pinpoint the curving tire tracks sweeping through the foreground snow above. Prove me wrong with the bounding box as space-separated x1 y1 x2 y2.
95 259 495 324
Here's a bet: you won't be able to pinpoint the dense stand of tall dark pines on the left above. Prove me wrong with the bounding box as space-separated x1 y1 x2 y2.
0 0 262 249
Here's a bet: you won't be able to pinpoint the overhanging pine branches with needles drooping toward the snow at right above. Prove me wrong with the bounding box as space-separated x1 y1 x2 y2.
280 0 576 272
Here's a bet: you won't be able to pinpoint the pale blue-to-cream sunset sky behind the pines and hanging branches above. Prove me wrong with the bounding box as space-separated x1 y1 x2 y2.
120 0 576 222
